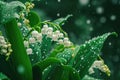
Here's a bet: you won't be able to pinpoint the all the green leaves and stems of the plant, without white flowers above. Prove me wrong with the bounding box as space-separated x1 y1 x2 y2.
0 0 116 80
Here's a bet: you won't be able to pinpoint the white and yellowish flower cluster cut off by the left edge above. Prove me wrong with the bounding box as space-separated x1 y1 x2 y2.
0 36 12 56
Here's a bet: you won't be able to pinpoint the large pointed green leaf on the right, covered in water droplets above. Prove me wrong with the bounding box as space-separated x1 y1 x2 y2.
72 32 116 78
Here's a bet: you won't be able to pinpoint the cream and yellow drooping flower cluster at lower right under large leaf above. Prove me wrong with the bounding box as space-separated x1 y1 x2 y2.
89 60 110 76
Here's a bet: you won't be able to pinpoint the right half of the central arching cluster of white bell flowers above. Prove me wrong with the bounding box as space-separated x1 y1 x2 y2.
41 25 71 47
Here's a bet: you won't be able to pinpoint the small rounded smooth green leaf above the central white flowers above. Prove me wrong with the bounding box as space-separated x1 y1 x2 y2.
27 11 41 30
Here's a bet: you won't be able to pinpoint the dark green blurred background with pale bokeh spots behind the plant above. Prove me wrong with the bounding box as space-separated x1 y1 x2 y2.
4 0 120 80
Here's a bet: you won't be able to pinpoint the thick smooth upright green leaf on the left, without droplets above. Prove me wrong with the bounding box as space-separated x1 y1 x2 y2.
4 19 32 80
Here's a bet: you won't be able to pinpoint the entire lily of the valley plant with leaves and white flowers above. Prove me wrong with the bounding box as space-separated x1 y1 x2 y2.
0 0 116 80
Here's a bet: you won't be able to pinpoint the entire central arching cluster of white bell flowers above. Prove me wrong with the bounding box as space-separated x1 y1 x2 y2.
24 25 71 54
